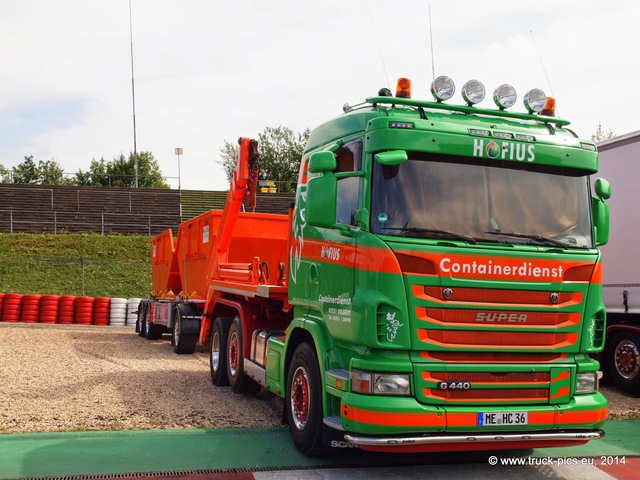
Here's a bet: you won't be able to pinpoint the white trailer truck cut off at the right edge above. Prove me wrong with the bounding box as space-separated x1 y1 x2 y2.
598 130 640 395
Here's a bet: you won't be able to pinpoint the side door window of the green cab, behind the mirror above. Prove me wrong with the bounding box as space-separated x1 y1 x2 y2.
336 140 362 226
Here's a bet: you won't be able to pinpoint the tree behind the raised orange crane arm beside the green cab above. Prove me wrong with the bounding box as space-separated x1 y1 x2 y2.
218 126 311 192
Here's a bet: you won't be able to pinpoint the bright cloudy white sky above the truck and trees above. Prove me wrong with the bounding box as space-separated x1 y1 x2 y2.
0 0 640 190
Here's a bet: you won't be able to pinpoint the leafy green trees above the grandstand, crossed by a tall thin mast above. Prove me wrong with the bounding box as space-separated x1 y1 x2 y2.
75 152 169 188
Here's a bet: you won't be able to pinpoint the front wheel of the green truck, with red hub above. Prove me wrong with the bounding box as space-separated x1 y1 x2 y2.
285 343 325 455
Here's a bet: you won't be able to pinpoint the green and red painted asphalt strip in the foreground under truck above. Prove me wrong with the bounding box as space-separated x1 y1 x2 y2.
0 420 640 480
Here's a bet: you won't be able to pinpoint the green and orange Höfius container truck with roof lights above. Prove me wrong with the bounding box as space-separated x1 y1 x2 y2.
138 77 610 455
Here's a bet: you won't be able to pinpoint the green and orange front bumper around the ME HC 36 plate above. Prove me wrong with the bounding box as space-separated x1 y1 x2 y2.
341 392 607 451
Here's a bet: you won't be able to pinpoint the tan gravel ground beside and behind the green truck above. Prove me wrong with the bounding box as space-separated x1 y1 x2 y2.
0 323 640 433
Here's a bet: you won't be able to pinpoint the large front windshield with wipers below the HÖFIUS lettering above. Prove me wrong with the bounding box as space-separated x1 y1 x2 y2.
371 152 592 248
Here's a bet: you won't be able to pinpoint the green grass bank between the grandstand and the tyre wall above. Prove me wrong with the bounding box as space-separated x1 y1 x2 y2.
0 233 151 298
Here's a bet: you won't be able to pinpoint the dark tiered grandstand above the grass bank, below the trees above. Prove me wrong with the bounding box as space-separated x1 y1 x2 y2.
0 183 293 236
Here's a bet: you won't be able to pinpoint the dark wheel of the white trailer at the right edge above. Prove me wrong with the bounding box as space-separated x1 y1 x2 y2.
607 332 640 395
